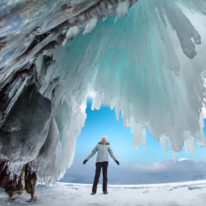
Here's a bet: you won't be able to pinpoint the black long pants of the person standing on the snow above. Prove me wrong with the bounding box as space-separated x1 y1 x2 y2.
92 162 108 193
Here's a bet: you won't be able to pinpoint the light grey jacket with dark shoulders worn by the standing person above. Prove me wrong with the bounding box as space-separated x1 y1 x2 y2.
86 142 117 162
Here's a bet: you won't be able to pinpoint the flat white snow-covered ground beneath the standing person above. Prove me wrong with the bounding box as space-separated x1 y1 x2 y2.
0 180 206 206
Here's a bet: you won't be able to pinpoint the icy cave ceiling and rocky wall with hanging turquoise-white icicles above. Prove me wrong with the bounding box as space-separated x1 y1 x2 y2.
0 0 206 181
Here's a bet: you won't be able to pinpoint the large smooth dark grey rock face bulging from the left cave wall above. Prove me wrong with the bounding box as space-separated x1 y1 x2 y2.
0 84 51 162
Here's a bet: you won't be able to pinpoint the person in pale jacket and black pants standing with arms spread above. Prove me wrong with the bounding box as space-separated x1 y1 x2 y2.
83 136 119 195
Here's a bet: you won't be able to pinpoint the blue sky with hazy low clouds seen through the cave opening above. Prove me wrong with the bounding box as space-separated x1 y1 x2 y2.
60 98 206 184
